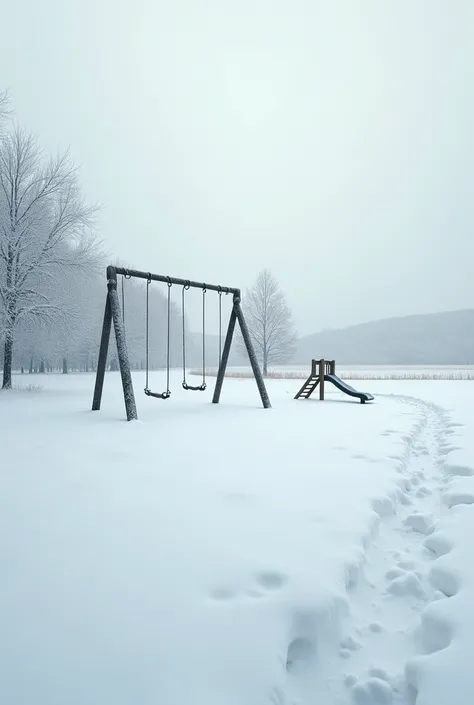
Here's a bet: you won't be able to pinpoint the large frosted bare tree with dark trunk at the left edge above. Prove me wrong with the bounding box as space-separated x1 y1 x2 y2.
0 128 98 388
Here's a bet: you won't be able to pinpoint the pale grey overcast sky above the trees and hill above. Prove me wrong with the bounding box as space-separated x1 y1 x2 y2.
0 0 474 334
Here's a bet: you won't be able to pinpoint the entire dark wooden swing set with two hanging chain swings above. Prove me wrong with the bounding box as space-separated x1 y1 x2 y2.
92 265 271 421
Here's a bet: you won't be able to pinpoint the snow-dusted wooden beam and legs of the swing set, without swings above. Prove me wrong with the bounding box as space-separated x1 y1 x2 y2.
92 265 271 421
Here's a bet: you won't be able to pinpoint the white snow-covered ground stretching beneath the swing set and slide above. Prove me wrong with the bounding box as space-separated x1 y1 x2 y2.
0 373 474 705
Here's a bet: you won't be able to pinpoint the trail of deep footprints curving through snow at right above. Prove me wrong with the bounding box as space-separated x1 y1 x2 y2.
284 397 474 705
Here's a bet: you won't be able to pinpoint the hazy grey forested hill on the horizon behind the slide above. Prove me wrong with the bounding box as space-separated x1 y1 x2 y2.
294 309 474 365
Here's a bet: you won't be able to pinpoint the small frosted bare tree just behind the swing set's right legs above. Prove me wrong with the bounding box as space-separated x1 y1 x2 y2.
239 269 296 377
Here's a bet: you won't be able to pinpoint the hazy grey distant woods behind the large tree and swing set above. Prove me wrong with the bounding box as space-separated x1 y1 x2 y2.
0 269 189 374
